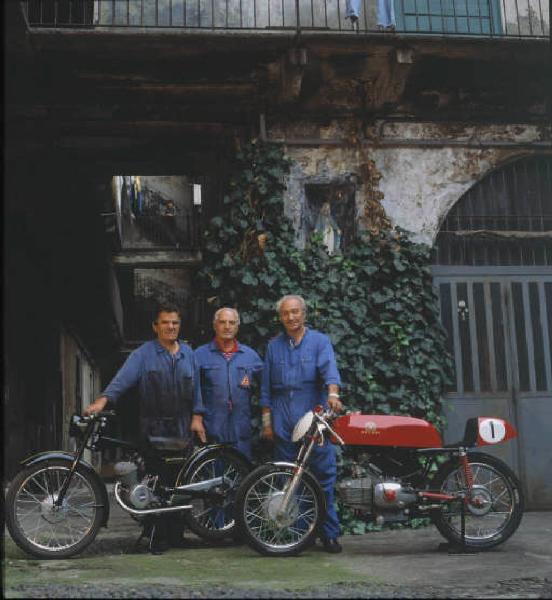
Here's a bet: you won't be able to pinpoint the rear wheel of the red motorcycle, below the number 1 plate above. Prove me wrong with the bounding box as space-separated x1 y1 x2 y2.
432 452 524 550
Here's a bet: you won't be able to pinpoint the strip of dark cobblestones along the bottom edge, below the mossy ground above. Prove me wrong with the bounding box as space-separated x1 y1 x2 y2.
6 577 552 598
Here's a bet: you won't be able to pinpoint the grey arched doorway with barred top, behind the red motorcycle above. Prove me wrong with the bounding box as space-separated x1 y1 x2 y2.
433 156 552 509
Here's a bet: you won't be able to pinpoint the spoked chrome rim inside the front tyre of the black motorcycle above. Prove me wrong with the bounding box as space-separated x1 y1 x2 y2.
14 467 97 552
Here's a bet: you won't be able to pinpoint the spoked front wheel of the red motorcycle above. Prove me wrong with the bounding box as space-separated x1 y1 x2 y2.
236 464 326 556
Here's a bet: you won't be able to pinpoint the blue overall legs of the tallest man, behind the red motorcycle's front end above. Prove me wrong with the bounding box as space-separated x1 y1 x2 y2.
274 438 340 539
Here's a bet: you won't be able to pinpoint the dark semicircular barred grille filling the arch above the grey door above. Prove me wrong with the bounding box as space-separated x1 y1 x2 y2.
435 156 552 266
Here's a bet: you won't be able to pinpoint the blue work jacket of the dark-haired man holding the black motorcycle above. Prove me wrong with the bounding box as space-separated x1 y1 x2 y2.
102 340 205 440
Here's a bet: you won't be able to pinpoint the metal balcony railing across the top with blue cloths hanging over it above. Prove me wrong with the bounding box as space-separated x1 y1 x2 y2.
24 0 550 39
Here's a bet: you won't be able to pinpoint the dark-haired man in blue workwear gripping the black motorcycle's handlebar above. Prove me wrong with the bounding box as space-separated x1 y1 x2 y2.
83 305 205 553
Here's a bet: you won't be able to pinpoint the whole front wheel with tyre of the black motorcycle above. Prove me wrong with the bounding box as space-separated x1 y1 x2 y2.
6 460 104 559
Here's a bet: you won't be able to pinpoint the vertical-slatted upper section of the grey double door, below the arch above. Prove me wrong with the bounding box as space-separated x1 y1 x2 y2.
435 274 552 394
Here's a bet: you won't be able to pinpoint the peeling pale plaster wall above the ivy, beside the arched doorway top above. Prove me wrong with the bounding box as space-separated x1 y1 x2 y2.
272 123 551 246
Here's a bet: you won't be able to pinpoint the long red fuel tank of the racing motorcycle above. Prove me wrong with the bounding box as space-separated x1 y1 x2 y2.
332 414 443 448
